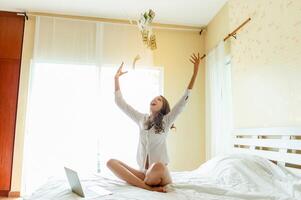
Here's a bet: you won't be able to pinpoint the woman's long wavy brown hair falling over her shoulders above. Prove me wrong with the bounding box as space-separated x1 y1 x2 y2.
144 95 176 134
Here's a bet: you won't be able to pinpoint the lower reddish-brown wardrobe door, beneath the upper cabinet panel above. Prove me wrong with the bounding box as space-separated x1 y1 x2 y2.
0 59 20 190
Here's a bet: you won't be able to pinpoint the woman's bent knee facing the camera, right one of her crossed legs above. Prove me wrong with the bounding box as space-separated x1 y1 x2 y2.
144 162 172 186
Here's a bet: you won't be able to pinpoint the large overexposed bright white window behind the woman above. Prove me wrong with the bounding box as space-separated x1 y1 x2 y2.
23 63 163 194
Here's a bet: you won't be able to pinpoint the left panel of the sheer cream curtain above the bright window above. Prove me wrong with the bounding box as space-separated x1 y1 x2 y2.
33 17 97 65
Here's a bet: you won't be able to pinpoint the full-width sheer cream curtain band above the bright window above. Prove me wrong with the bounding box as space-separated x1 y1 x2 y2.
34 17 153 66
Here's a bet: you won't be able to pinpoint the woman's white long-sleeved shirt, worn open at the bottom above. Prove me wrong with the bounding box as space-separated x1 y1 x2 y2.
115 89 191 171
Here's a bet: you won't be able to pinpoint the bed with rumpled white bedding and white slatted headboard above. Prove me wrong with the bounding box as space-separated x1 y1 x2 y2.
25 128 301 200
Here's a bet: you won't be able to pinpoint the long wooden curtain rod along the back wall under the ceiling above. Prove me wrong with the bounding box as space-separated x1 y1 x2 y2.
27 12 203 32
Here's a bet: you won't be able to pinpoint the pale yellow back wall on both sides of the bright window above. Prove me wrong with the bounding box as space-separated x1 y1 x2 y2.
12 17 205 191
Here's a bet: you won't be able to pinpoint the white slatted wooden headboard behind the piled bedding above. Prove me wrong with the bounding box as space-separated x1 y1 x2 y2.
233 127 301 177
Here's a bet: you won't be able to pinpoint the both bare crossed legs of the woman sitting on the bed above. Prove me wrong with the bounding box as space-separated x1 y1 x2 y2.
107 159 171 192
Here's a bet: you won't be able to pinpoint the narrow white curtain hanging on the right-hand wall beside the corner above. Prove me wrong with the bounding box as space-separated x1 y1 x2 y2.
206 42 232 160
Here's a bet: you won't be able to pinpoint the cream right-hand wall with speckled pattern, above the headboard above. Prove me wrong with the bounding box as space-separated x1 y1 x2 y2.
206 0 301 128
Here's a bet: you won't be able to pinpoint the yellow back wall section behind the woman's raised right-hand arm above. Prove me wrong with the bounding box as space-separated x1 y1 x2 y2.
154 29 205 170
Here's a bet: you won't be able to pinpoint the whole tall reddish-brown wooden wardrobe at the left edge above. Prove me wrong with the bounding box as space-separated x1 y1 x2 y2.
0 11 24 196
